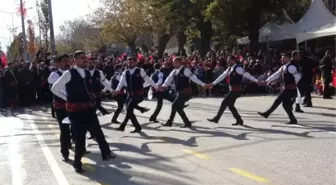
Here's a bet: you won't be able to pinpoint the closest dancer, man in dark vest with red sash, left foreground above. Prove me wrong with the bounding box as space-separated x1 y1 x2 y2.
51 51 115 173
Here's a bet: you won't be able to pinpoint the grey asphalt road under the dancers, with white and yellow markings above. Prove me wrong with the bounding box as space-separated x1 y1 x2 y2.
0 96 336 185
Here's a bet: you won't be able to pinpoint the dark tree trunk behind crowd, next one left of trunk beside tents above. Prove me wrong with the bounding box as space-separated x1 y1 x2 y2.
199 21 213 57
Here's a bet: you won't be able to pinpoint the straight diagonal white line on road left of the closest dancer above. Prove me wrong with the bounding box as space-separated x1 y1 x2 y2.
25 109 69 185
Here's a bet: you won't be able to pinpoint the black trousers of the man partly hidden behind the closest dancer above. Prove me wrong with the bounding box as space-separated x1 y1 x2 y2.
55 109 71 158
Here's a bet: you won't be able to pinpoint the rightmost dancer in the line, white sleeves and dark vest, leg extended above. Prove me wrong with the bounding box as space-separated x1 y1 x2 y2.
258 51 301 124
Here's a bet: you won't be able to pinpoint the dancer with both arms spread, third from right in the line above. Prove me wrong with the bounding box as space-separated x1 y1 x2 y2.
160 57 206 128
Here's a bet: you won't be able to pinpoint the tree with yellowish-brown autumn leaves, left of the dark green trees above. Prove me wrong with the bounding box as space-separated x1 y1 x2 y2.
95 0 153 53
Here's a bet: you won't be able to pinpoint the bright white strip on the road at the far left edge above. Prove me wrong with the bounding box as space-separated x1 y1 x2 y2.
6 109 24 185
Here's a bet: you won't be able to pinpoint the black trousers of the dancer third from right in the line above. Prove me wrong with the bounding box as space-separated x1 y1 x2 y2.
168 93 191 125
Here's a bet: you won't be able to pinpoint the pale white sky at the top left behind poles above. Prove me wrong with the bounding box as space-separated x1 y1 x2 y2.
0 0 100 51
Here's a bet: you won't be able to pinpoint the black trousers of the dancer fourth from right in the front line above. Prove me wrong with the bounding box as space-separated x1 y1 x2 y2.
120 95 144 130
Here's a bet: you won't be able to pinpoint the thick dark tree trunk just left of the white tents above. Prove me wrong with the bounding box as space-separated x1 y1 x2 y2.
245 1 262 56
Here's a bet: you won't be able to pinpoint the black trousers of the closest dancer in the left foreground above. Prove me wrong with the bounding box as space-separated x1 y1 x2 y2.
68 109 111 166
